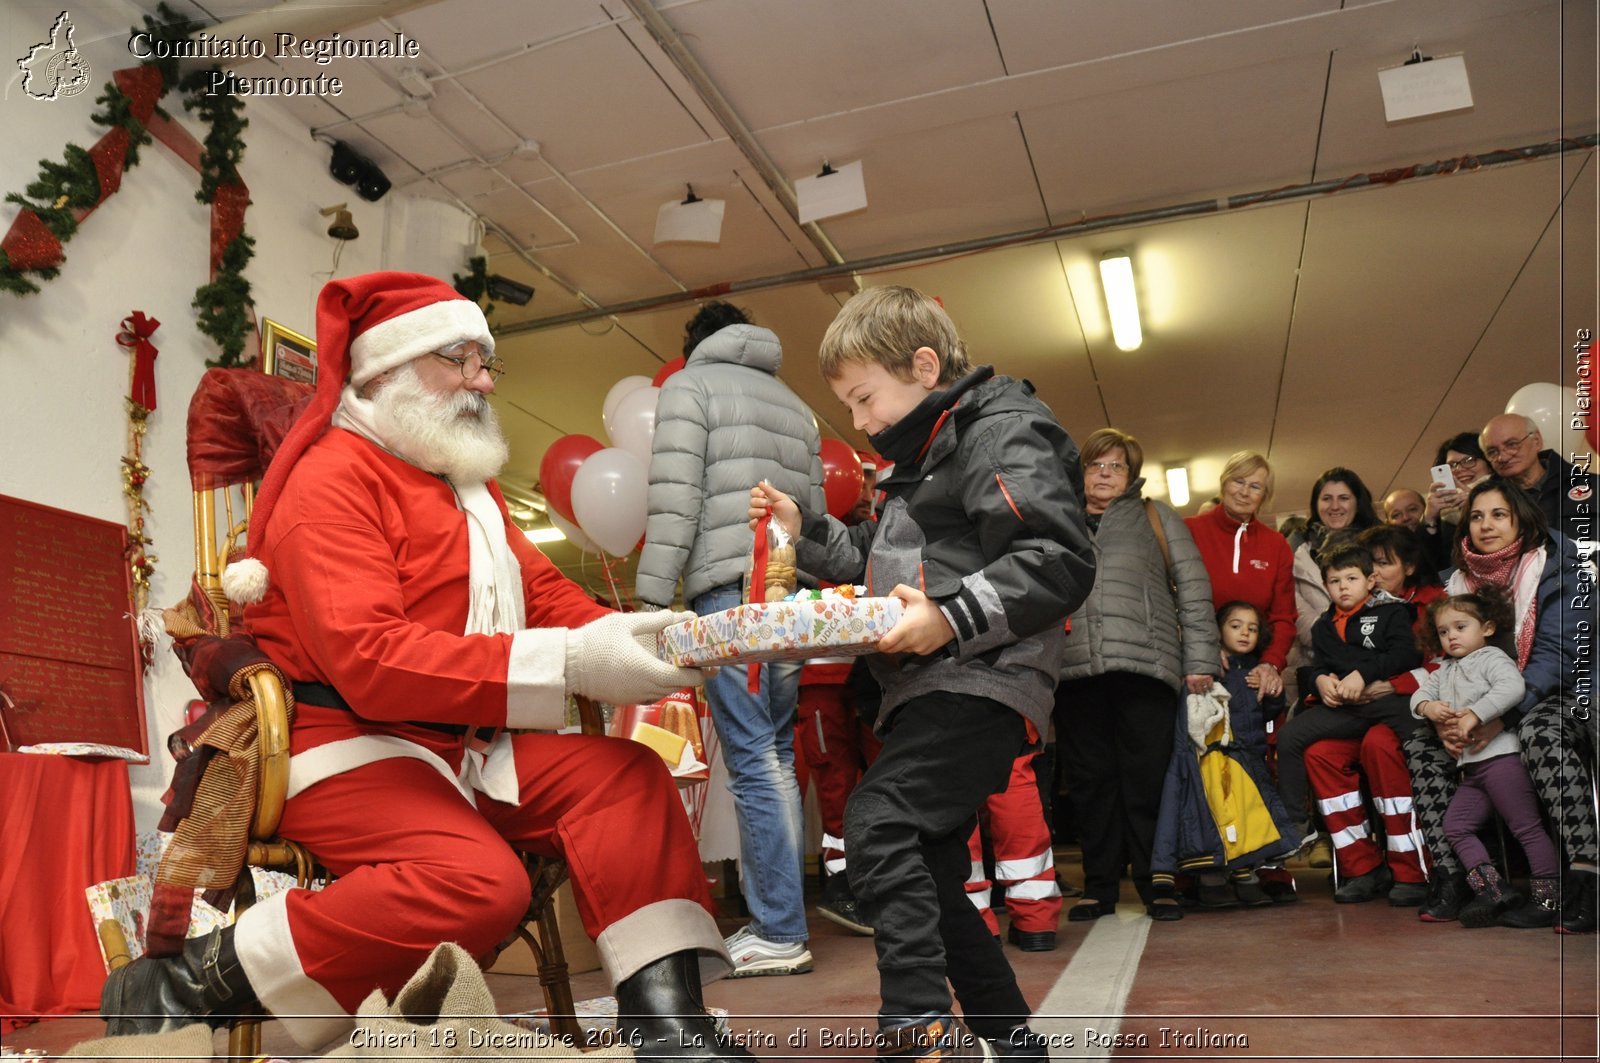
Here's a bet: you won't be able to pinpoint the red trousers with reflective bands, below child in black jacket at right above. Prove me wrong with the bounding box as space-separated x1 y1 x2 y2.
1306 724 1427 882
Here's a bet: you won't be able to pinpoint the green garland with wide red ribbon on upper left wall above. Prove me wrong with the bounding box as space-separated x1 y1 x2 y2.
0 3 254 367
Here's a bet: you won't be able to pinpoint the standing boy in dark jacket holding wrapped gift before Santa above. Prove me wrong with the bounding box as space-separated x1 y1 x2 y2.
750 288 1094 1060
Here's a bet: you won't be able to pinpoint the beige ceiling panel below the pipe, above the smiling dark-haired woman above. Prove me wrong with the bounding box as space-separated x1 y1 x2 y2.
1274 162 1560 505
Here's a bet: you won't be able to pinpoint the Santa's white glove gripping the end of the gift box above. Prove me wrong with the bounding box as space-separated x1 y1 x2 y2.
566 610 706 704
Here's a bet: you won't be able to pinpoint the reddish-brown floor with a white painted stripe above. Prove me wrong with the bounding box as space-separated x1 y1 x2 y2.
5 860 1600 1060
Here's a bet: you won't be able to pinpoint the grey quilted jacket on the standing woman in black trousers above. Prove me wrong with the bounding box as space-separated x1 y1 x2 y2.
1061 479 1222 690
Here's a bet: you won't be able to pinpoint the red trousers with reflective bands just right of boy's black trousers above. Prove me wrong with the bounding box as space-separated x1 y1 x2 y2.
966 752 1061 933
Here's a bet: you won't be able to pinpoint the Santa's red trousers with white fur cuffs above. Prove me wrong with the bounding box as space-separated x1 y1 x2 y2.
235 733 720 1044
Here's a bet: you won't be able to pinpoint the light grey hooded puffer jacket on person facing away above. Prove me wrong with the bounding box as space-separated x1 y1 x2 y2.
635 325 826 605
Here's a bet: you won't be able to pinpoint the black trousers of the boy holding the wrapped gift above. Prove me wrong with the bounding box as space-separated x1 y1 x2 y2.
845 692 1029 1037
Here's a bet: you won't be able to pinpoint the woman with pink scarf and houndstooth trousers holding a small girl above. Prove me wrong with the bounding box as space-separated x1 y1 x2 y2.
1405 479 1597 933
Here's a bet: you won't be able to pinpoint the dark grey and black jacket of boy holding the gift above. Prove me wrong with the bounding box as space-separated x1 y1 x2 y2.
797 370 1094 735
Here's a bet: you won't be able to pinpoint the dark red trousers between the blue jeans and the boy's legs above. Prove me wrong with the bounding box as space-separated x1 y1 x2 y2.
795 681 883 874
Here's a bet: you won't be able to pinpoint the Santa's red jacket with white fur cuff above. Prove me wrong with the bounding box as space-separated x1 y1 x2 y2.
245 429 608 767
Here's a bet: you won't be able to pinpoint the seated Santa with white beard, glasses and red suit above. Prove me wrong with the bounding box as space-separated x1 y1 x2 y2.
101 272 749 1060
